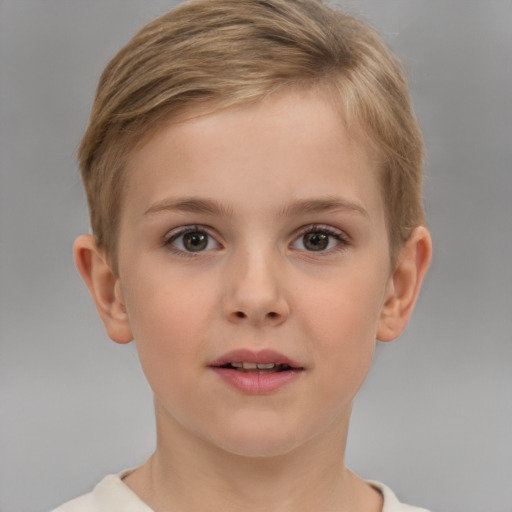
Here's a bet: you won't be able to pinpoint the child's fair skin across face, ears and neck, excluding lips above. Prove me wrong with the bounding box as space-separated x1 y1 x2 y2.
75 91 431 512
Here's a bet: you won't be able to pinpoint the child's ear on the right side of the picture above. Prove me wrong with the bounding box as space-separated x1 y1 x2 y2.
377 226 432 341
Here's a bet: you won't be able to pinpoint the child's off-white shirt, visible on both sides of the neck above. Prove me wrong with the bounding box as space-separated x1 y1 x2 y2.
52 470 428 512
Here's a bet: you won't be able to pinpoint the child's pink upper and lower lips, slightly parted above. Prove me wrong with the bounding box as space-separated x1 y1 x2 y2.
209 349 304 395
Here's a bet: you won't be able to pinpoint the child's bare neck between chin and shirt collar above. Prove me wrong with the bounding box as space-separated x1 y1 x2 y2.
125 404 381 512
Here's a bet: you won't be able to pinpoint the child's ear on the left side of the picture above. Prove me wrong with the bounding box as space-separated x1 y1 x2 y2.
73 235 133 343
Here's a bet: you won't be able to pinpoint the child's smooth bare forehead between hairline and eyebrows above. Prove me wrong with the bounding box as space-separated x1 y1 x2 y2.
121 90 381 222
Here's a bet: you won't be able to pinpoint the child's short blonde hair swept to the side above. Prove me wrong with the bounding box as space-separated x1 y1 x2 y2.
78 0 424 265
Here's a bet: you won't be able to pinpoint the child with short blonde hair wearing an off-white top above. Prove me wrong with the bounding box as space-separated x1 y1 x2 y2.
57 0 431 512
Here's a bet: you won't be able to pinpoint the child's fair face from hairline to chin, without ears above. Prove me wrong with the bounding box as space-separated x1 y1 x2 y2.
117 92 391 456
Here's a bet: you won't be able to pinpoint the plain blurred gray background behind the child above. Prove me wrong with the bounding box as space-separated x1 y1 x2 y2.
0 0 512 512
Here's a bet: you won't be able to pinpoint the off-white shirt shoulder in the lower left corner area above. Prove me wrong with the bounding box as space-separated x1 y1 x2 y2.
52 471 152 512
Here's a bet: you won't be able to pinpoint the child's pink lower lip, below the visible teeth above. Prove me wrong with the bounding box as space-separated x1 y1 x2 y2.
212 367 303 395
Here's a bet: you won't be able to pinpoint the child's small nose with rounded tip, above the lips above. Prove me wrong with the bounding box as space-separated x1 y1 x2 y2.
224 251 290 326
